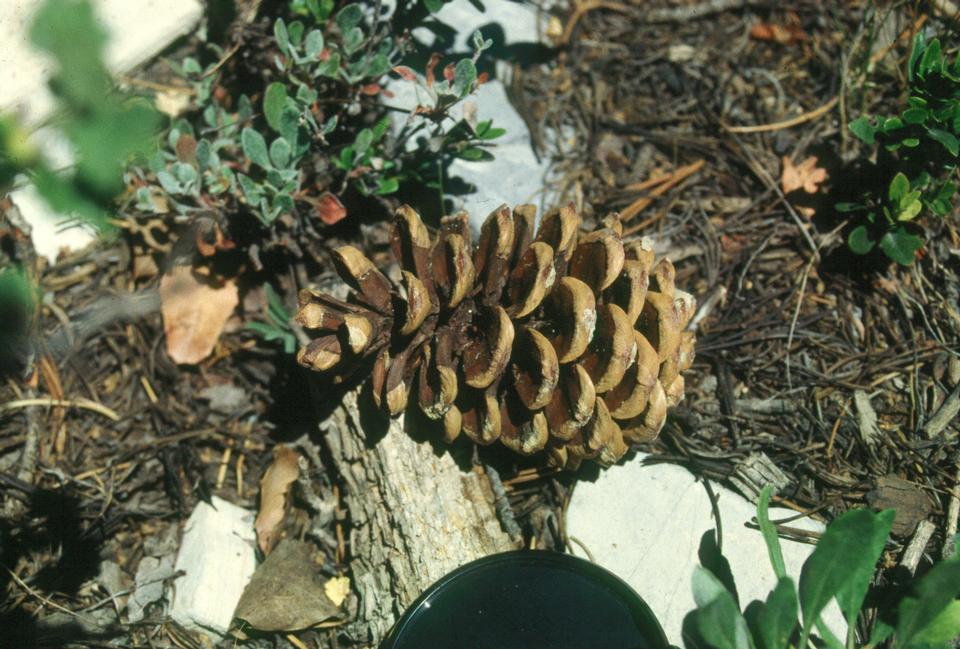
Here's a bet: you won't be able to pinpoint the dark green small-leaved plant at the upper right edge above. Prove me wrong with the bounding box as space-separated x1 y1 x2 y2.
836 34 960 265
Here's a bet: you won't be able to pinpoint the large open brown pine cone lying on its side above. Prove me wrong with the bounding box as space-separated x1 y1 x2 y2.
296 205 695 468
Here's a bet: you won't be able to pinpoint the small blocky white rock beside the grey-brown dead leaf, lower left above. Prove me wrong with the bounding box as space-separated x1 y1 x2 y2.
170 496 256 633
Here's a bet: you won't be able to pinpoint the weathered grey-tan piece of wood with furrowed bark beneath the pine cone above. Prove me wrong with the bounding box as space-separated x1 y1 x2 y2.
321 392 514 646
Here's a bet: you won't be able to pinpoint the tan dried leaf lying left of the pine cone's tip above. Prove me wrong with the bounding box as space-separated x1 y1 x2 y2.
160 266 239 363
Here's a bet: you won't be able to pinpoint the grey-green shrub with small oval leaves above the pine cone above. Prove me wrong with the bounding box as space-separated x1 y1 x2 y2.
145 0 503 226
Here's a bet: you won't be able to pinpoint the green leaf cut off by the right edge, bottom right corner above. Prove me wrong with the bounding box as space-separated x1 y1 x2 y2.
896 556 960 647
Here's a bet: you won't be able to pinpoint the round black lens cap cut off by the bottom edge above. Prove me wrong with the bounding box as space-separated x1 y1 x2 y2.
380 550 669 649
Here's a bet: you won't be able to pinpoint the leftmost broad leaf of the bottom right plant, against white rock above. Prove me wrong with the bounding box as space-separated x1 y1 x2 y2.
691 566 752 649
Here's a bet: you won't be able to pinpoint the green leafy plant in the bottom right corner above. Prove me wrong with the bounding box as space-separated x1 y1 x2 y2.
684 487 960 649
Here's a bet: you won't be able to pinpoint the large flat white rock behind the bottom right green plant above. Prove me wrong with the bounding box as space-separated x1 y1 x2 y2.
567 455 846 646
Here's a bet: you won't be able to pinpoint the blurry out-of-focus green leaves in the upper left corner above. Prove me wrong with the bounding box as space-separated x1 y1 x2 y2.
0 0 160 227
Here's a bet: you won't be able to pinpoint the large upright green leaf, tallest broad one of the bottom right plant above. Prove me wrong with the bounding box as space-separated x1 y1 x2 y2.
797 509 889 647
